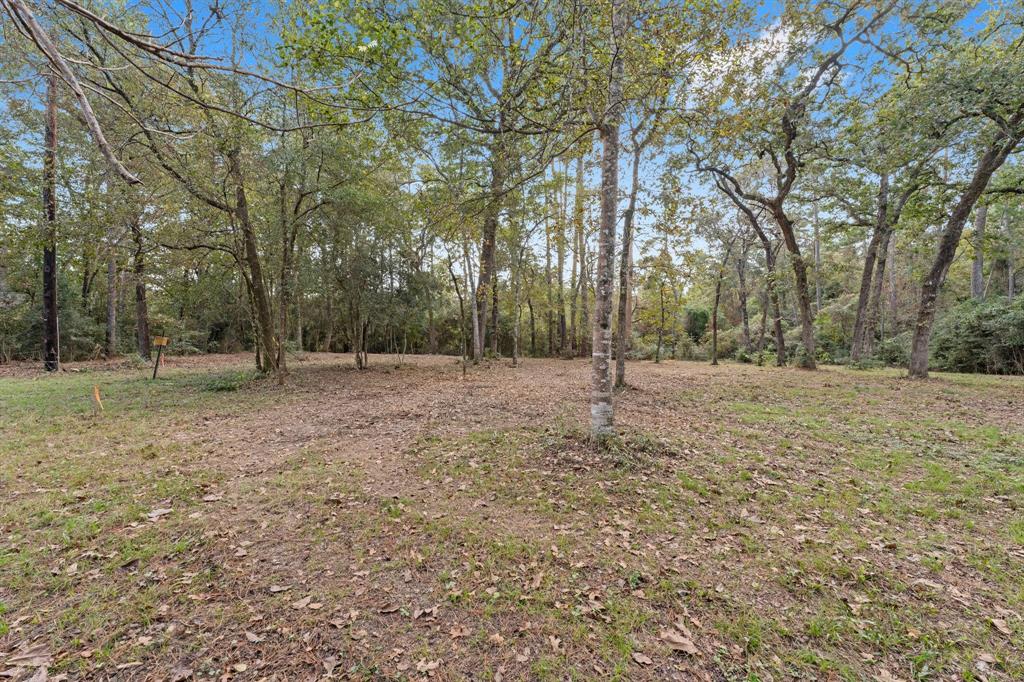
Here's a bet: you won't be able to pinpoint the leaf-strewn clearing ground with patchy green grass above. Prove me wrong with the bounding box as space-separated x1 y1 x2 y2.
0 354 1024 682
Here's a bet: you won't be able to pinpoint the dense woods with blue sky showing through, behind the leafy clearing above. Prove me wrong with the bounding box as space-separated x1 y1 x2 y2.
0 0 1024 411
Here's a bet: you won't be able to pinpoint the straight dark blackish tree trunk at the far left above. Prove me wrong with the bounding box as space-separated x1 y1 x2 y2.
43 73 60 372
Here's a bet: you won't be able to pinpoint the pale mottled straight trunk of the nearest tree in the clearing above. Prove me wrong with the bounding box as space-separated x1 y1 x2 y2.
590 0 627 440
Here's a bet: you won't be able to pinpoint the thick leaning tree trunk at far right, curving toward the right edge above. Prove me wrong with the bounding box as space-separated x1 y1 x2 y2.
909 129 1024 379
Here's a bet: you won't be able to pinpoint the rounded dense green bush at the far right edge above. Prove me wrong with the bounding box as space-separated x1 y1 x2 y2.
931 298 1024 374
